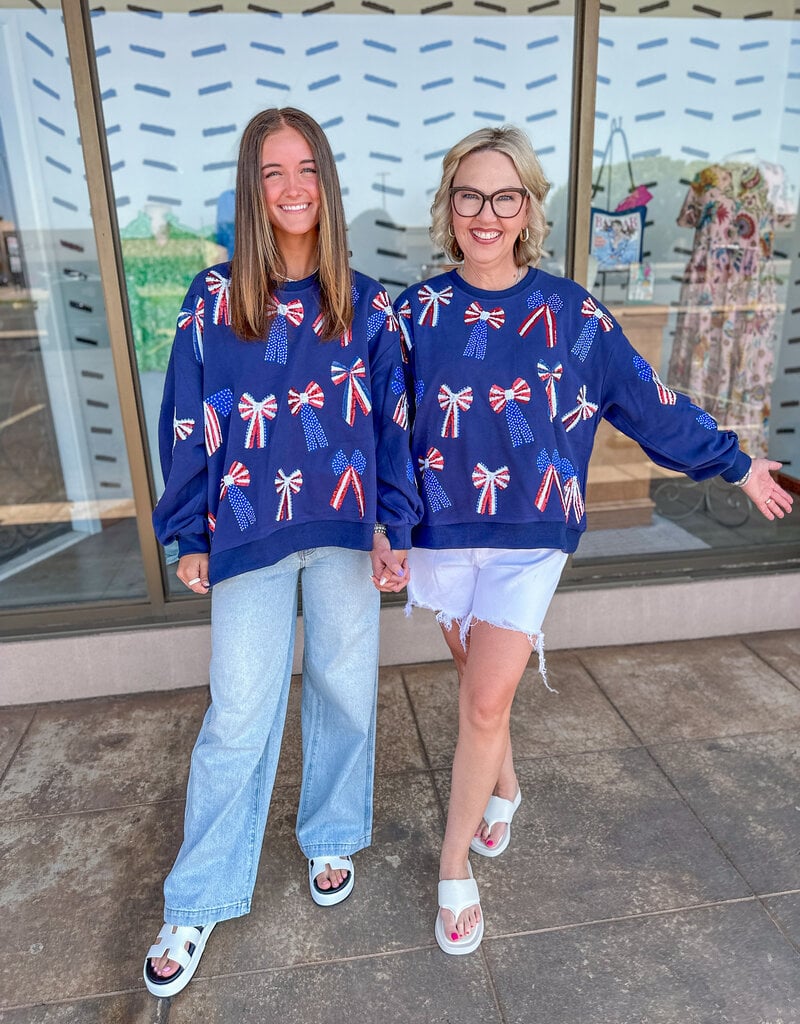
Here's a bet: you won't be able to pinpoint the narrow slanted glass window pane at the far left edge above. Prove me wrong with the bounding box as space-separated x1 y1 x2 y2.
0 2 145 609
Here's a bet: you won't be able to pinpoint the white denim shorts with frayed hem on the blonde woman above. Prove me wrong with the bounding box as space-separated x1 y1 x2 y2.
407 548 569 688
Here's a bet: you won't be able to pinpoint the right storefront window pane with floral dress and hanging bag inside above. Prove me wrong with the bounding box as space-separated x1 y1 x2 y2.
575 0 800 565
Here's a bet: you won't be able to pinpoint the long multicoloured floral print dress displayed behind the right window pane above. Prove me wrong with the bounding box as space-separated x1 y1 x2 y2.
669 164 777 457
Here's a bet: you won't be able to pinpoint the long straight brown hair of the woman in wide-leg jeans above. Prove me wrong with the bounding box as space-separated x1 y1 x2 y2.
230 106 353 341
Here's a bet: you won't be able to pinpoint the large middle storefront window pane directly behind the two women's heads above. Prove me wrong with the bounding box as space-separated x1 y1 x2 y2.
86 0 573 593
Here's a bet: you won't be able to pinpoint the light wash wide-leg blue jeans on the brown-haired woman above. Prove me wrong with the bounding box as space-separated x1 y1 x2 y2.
164 548 380 925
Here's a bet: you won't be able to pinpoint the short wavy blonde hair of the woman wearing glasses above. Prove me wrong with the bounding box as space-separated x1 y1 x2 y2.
430 125 550 266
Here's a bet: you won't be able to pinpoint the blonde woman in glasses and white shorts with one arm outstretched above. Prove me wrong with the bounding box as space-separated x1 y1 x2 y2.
396 126 792 954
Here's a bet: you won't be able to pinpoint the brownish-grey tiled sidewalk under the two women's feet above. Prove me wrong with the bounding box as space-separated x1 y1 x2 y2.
0 631 800 1024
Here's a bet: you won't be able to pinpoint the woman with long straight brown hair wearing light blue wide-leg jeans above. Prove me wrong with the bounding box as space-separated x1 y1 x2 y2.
144 108 420 996
